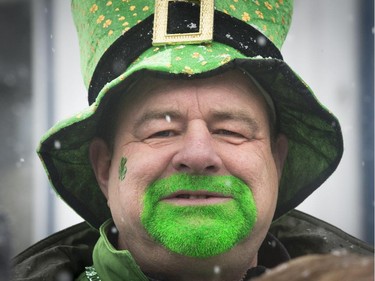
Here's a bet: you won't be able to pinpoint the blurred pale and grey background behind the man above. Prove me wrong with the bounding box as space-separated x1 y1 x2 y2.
0 0 374 255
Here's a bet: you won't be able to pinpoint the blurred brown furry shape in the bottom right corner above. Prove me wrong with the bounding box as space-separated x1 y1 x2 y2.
254 253 374 281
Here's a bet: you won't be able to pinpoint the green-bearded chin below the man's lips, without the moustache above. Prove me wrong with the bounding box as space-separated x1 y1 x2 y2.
144 200 256 259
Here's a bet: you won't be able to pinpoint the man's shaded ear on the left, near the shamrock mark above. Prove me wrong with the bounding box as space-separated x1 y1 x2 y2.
89 138 111 199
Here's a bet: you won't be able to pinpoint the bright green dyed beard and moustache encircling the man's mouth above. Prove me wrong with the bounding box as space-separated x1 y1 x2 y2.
141 174 257 258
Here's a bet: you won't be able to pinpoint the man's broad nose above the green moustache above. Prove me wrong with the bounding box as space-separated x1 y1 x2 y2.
172 121 222 175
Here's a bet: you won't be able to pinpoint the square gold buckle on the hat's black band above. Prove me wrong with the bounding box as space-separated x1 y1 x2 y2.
152 0 215 46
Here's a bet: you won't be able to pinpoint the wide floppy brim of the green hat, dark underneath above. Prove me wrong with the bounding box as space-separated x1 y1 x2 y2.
38 42 343 228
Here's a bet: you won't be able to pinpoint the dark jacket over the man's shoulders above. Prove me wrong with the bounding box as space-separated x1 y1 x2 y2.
13 210 374 281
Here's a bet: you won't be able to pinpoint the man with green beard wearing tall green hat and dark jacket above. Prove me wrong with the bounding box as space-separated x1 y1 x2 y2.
11 0 372 280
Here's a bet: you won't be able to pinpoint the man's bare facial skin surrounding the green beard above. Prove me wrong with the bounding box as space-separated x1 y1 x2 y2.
91 71 287 278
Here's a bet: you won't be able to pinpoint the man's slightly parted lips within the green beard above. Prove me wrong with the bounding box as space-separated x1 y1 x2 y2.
160 190 232 206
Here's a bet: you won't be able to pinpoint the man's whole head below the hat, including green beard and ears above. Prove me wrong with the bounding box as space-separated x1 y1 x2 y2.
90 71 287 280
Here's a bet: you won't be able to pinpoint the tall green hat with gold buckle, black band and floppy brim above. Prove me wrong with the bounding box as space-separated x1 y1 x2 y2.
38 0 343 227
